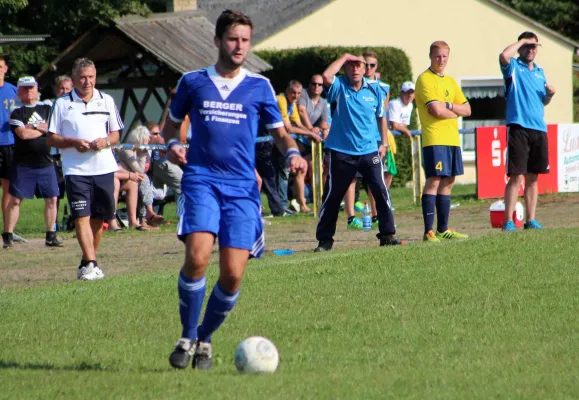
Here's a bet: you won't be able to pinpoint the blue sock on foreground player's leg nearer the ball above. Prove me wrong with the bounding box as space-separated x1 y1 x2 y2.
199 282 239 342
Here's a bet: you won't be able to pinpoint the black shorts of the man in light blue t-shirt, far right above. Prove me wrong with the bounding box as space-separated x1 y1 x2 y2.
507 124 549 176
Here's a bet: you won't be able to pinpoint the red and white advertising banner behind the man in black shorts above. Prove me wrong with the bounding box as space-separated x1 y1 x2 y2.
476 125 564 199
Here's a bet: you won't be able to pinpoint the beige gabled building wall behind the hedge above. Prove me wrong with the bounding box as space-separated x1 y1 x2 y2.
255 0 574 123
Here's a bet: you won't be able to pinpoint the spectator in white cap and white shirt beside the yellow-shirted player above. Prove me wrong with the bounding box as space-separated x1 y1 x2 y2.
384 81 414 187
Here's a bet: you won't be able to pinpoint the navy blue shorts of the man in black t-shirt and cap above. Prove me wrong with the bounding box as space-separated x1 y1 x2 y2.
9 165 60 199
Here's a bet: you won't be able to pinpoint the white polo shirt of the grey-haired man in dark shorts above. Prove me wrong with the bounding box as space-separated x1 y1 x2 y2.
48 89 123 176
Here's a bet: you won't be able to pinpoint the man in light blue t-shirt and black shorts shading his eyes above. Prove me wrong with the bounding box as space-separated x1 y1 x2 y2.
499 32 555 232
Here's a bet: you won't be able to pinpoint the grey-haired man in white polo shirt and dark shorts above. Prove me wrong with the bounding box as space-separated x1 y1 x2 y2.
48 58 123 280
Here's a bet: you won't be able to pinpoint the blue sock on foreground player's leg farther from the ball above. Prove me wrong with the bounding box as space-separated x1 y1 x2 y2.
178 272 205 340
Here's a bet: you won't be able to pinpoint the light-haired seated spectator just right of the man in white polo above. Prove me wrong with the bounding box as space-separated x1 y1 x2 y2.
117 126 165 229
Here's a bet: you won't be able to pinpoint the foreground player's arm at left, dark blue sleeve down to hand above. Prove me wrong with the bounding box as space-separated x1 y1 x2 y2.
161 75 191 165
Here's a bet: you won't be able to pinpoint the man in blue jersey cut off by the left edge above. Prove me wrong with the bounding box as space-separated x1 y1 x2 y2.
0 56 18 241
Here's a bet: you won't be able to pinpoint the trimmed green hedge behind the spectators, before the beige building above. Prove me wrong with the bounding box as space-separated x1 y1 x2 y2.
255 47 417 187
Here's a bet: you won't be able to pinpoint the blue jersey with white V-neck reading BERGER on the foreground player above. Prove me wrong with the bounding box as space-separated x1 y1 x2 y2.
170 66 284 186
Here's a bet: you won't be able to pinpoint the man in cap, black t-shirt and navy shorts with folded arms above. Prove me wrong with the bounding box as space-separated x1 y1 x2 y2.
2 76 62 249
